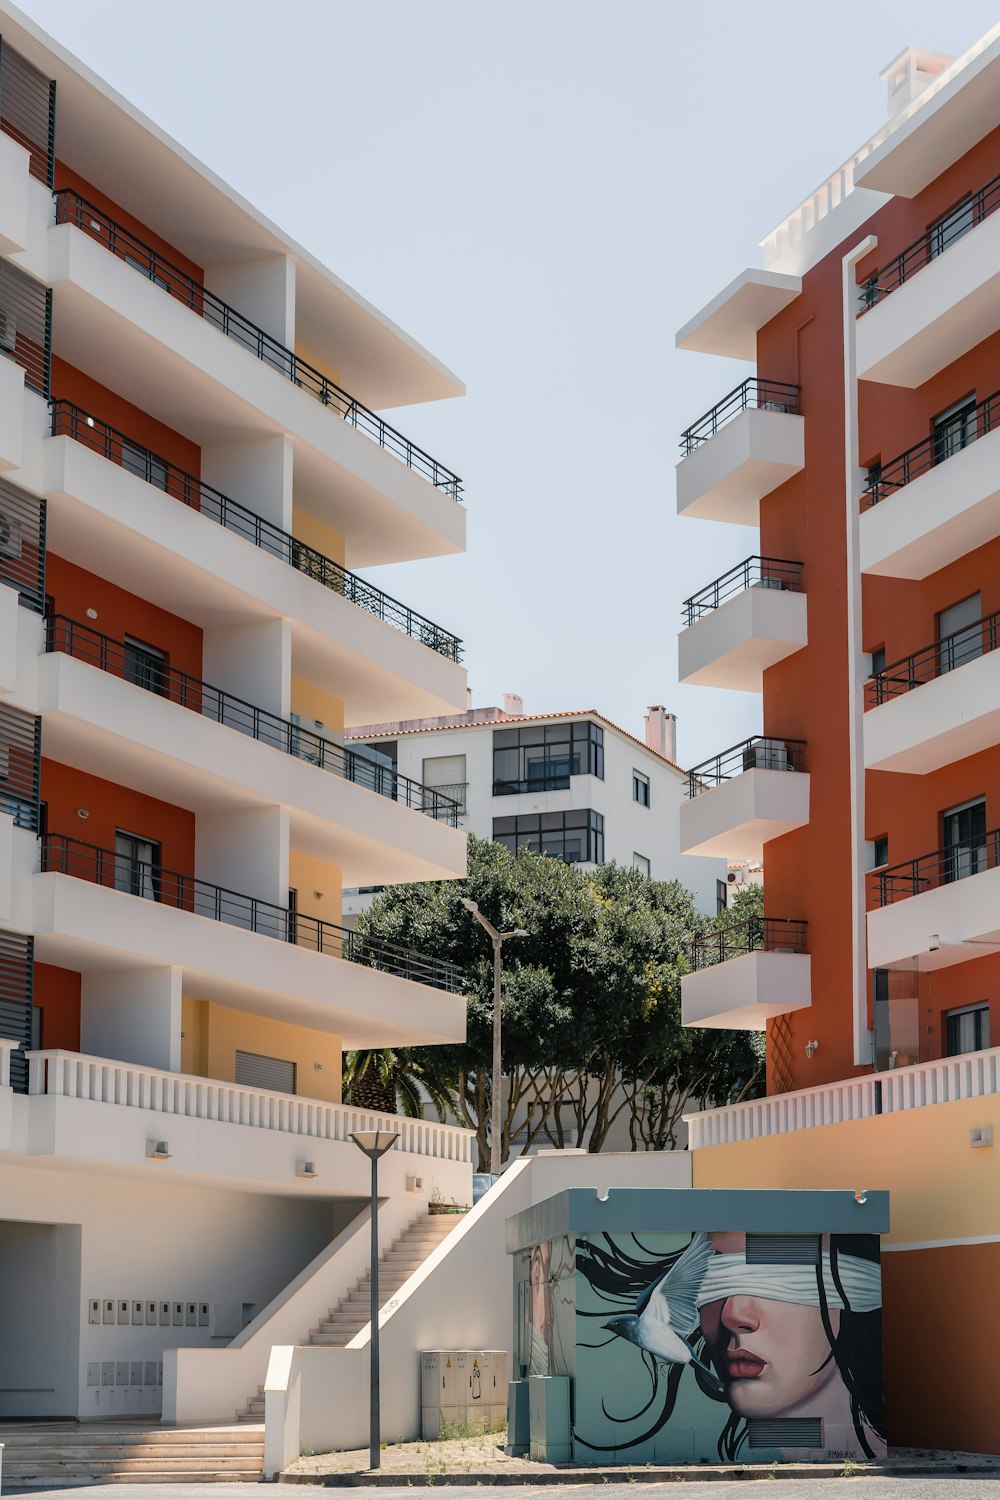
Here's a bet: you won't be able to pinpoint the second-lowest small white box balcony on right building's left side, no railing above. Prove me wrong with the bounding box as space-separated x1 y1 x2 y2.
679 768 810 860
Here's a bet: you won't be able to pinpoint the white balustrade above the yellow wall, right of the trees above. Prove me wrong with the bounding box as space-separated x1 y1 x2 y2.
684 1047 1000 1151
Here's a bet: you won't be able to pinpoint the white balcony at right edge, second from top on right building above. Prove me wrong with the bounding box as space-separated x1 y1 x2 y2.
859 429 1000 579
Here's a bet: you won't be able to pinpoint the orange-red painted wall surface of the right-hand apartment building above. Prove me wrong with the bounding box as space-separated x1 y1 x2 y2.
757 108 1000 1092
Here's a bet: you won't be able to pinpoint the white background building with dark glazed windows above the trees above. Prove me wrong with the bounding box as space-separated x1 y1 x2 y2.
345 693 727 917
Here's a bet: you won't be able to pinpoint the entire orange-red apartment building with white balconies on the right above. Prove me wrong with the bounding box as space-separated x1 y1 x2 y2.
676 27 1000 1452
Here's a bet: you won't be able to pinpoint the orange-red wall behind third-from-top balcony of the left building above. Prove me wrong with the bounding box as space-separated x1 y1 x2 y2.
45 552 202 677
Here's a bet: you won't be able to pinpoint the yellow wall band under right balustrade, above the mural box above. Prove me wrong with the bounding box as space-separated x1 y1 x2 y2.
693 1097 1000 1245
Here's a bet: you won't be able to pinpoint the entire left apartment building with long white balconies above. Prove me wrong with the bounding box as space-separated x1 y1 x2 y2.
0 0 471 1421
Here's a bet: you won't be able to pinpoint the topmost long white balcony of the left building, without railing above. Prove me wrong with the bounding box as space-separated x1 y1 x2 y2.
46 224 465 567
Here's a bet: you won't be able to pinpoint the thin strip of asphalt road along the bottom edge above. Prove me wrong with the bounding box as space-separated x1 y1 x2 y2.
3 1475 1000 1500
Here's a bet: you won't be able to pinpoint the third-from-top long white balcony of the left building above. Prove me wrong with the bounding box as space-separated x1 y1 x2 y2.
36 648 466 885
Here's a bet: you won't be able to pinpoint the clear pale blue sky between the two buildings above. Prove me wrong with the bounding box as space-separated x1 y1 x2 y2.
21 0 997 765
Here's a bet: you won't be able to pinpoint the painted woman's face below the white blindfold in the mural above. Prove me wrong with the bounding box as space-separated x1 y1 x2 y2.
702 1296 840 1416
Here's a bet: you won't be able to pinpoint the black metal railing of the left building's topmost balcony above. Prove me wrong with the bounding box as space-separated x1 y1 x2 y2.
55 189 462 500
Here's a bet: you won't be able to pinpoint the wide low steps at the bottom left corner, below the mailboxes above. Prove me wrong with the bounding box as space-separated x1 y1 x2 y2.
0 1421 264 1491
